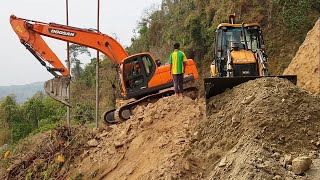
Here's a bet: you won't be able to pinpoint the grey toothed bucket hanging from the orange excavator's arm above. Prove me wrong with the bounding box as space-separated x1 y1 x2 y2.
44 76 71 107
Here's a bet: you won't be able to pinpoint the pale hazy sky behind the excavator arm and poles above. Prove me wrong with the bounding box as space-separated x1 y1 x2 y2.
0 0 161 86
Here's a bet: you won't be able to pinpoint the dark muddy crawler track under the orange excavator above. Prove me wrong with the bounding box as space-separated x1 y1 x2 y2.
103 87 198 125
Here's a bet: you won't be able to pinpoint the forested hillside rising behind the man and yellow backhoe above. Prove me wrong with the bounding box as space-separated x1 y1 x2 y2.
129 0 320 76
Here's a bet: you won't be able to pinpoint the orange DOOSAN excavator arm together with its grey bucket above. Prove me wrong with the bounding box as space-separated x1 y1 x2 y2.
10 15 128 106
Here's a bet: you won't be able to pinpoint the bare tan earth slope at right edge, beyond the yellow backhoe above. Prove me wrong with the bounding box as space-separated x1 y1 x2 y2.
284 20 320 93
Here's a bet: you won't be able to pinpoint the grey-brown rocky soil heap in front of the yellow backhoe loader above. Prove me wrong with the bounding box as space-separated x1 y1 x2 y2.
187 78 320 179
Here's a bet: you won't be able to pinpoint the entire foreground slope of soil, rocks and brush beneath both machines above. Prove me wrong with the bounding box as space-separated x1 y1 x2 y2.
0 78 320 179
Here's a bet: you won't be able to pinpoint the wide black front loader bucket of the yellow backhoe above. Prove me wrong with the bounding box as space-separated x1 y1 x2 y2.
204 75 297 101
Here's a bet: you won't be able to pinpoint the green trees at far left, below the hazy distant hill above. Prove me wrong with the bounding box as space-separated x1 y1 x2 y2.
0 93 66 145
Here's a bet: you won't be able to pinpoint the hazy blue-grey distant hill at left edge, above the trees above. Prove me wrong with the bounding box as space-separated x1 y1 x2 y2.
0 82 44 104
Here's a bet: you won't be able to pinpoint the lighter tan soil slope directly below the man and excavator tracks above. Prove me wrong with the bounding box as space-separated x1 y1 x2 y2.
69 96 205 179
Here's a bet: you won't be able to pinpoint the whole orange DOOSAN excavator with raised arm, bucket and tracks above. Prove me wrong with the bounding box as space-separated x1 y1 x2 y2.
10 15 198 124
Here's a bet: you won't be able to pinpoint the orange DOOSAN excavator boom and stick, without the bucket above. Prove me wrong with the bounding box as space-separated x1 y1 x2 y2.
10 15 128 68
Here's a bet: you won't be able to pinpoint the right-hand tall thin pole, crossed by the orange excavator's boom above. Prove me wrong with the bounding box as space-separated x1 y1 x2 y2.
96 0 100 128
